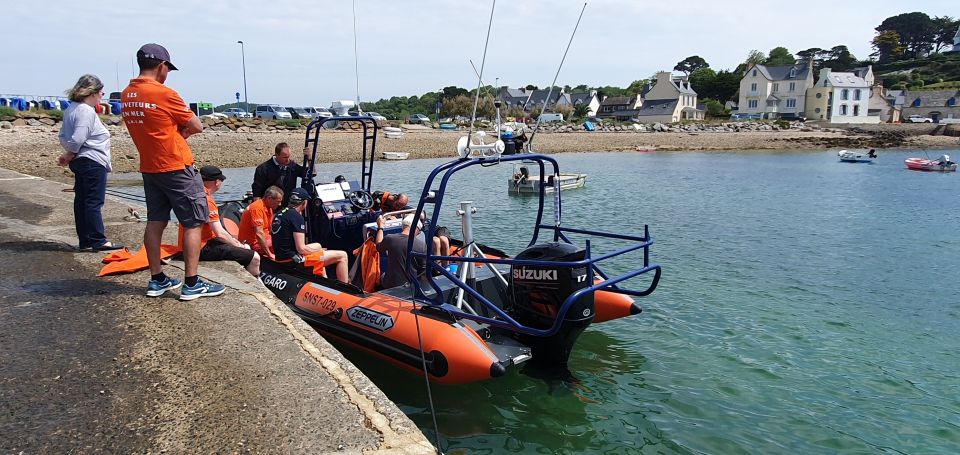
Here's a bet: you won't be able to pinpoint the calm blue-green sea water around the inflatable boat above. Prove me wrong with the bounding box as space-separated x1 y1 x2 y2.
125 151 960 454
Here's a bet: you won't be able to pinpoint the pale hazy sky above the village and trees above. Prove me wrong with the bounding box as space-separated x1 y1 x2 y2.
0 0 960 106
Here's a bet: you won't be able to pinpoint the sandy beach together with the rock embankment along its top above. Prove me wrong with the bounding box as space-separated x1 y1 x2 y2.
0 114 960 180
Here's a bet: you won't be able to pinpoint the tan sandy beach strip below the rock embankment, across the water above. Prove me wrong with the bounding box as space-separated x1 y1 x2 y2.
0 125 960 180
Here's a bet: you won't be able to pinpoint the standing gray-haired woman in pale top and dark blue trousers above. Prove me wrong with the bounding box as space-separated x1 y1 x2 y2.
57 74 123 251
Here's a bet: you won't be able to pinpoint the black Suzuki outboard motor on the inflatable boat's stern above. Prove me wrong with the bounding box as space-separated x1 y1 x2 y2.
510 243 595 369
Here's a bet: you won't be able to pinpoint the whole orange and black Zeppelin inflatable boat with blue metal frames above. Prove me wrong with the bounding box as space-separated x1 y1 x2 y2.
251 117 660 384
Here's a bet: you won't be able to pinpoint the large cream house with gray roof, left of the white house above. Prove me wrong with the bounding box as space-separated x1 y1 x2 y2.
737 61 813 119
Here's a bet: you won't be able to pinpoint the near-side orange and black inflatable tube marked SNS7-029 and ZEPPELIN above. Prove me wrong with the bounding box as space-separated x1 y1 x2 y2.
261 261 530 384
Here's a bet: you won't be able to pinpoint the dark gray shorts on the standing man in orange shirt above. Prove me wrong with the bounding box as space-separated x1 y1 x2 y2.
142 166 210 228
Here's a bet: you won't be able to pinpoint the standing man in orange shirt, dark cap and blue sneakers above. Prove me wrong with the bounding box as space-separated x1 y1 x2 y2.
121 43 224 300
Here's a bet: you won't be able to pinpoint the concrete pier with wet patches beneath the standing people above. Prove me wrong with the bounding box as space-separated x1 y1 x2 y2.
0 168 434 454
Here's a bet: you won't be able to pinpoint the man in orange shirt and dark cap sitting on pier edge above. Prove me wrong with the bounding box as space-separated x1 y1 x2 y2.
188 166 260 277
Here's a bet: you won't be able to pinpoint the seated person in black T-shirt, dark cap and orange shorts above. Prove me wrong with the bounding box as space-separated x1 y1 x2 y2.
270 188 348 283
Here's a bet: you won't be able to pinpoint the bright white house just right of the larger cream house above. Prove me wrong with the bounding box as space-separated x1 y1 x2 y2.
805 68 880 123
